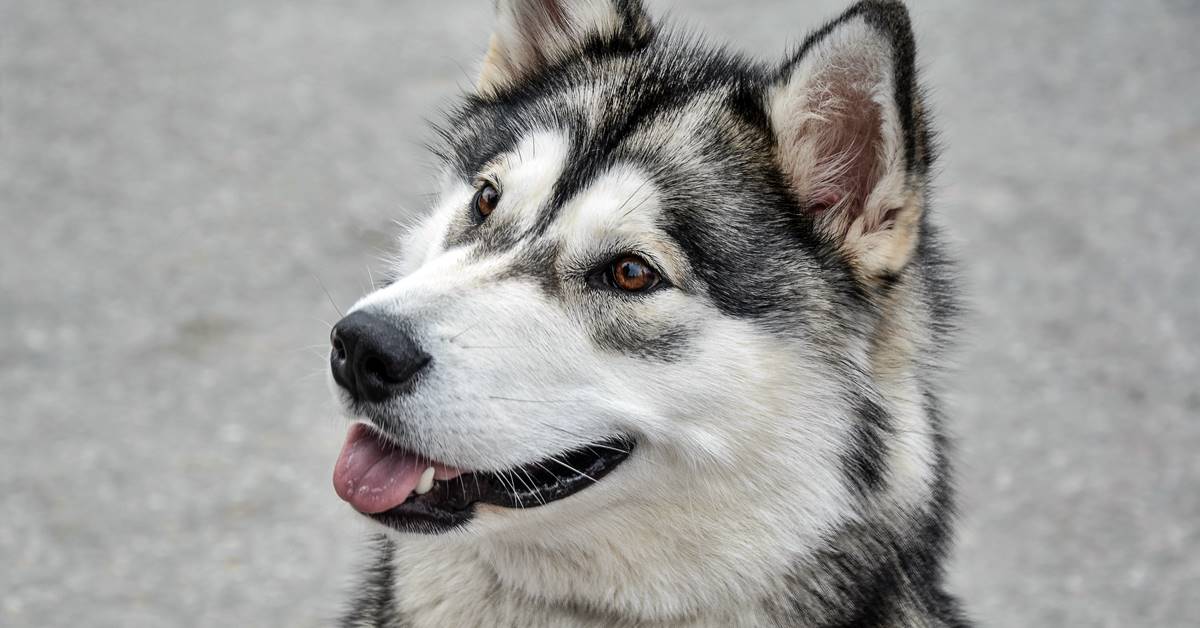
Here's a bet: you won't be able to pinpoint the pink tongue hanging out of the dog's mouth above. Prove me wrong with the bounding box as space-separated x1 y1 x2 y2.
334 423 430 514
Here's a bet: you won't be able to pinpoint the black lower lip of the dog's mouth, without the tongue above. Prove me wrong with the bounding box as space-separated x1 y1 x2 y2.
368 437 635 534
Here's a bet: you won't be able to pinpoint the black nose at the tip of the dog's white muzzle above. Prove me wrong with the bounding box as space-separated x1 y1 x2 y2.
329 311 430 401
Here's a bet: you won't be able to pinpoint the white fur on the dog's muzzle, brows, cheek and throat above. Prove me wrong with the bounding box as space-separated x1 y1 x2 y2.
328 127 902 626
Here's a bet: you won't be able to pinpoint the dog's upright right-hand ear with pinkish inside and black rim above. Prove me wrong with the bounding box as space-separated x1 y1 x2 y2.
767 0 930 281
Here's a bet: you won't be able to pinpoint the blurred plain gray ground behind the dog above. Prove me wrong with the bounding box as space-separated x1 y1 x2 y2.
0 0 1200 627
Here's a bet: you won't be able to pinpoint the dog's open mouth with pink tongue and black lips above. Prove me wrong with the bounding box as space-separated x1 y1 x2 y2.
334 423 634 533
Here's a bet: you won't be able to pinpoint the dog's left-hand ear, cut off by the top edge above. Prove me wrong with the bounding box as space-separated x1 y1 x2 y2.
478 0 654 95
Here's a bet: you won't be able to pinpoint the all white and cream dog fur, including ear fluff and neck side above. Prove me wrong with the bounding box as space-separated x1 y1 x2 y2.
333 7 950 627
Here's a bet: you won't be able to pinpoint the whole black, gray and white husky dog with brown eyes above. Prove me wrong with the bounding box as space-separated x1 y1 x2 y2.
330 0 966 628
